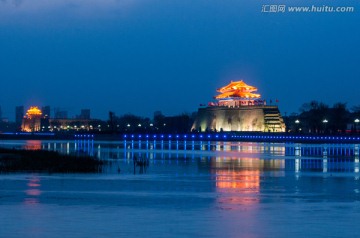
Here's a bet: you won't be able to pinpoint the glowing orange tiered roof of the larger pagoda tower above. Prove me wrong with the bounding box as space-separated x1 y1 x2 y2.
215 80 260 99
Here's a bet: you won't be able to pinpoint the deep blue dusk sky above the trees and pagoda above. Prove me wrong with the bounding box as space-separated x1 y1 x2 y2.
0 0 360 120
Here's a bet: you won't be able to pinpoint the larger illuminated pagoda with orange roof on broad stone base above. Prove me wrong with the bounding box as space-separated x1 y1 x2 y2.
192 80 285 132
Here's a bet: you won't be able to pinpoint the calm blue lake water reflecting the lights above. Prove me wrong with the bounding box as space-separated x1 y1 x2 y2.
0 140 360 238
